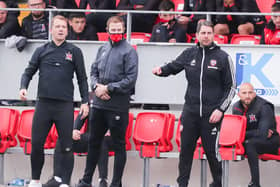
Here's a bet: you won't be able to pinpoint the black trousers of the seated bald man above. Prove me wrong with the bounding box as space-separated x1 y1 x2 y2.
244 135 279 186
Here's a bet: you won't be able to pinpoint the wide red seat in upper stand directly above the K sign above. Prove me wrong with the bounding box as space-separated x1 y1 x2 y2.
230 34 261 45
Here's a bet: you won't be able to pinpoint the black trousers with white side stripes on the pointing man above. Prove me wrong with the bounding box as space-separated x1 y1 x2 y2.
177 110 222 187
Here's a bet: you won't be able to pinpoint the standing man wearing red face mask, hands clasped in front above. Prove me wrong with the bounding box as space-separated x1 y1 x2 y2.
77 16 138 187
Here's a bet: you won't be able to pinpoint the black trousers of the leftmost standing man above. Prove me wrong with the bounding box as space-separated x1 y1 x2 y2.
31 99 74 184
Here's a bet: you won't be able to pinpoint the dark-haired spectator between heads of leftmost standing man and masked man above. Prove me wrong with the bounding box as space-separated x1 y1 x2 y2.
67 12 98 40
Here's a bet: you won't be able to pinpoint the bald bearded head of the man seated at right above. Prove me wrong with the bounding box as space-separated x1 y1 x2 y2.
238 83 256 106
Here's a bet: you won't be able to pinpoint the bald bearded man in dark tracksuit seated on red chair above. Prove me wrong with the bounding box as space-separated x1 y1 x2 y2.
232 83 279 187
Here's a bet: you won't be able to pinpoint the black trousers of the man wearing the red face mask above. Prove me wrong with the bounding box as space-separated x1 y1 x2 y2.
83 108 128 187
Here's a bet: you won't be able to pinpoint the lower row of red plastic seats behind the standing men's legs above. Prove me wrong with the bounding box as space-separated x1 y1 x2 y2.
0 108 280 160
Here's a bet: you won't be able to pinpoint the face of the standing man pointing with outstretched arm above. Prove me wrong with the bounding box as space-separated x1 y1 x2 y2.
196 25 214 46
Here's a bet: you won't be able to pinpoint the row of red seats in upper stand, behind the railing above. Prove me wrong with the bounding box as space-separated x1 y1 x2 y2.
97 32 261 45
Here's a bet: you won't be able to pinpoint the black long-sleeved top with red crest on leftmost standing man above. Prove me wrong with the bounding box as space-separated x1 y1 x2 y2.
20 41 88 103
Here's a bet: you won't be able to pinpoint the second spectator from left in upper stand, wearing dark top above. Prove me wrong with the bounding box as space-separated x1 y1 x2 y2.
22 0 49 39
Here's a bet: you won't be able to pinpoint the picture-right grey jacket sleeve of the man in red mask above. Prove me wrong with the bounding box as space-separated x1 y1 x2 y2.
107 49 138 94
